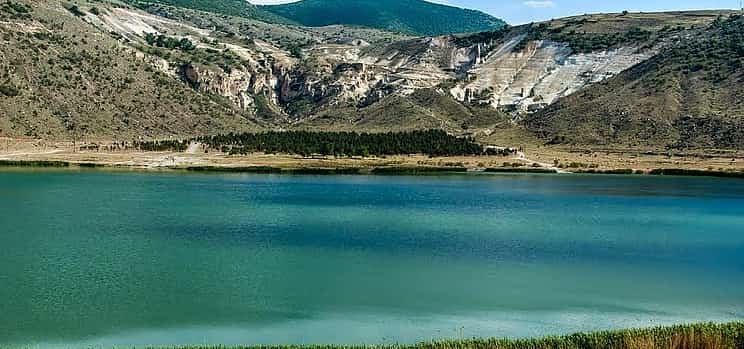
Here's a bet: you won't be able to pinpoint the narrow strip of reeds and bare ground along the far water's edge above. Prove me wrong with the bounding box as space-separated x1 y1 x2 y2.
0 160 744 178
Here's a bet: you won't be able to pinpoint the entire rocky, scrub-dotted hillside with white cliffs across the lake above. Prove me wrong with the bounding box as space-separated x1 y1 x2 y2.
0 0 744 148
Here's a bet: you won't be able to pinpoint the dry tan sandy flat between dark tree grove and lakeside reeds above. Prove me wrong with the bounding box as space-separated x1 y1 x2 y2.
0 138 744 172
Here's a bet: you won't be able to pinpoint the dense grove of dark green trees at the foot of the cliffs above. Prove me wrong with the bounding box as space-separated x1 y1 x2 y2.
190 130 506 156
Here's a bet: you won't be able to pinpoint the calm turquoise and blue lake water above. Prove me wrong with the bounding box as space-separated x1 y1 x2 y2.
0 171 744 348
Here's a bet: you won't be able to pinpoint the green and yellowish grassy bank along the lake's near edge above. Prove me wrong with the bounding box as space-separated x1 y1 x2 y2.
96 322 744 349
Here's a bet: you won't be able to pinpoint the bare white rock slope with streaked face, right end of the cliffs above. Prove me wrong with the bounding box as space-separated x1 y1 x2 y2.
451 40 654 111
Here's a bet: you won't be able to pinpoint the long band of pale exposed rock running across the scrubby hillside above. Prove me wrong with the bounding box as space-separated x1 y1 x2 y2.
89 8 654 117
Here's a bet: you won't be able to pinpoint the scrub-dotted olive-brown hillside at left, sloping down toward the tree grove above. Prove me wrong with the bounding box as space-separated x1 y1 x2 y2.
0 1 256 139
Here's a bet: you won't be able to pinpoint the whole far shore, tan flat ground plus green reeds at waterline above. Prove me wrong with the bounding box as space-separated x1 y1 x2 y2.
0 139 744 178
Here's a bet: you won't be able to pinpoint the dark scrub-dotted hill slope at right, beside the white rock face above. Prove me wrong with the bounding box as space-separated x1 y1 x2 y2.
525 15 744 149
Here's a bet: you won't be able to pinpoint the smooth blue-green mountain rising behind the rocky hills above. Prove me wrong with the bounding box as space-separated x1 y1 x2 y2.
262 0 506 35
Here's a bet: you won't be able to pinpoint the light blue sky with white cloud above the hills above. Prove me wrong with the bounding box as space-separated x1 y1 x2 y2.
249 0 739 24
